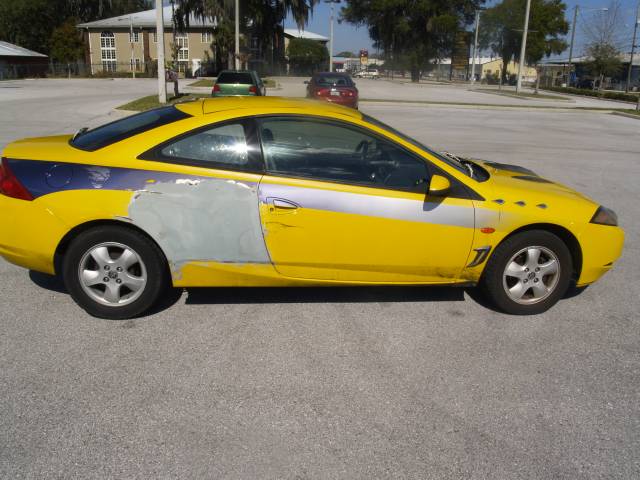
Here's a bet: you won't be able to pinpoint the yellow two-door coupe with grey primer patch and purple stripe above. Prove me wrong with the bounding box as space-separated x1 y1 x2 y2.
0 97 624 319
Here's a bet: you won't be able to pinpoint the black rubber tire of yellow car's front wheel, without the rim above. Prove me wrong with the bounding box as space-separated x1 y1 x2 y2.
480 230 573 315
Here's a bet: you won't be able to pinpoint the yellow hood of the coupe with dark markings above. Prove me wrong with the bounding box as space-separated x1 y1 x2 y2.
471 159 598 211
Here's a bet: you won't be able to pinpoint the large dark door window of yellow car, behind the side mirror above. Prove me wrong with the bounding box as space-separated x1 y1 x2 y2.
258 117 429 192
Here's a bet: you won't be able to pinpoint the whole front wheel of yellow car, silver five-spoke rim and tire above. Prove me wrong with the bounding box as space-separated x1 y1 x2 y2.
481 230 573 315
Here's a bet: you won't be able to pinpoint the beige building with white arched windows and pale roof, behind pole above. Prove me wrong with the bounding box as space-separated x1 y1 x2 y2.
77 7 214 74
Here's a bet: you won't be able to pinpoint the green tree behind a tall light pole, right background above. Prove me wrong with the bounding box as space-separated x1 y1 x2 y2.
480 0 569 82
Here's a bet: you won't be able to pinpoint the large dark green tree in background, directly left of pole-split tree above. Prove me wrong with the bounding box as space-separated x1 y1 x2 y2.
341 0 484 81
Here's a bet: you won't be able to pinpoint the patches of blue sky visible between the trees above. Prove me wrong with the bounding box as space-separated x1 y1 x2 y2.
285 0 640 57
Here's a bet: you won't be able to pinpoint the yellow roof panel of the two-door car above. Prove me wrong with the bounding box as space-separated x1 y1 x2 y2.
175 96 362 119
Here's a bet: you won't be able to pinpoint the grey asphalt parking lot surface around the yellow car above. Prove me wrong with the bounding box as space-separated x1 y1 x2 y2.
0 80 640 479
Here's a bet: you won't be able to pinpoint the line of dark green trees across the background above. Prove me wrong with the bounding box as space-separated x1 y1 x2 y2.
0 0 617 84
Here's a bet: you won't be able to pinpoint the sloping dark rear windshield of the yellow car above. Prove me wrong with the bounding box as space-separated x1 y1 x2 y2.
71 106 191 152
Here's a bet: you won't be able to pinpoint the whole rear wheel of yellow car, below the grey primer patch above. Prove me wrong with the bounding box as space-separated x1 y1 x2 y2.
63 226 169 320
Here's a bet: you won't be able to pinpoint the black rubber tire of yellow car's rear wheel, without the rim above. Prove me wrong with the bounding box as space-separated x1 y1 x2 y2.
62 225 169 320
